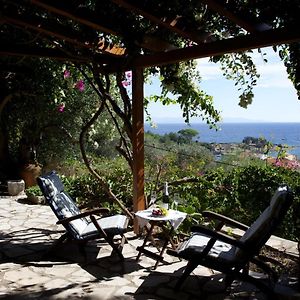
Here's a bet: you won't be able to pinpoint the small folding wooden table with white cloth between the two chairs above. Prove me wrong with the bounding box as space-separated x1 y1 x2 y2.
135 209 186 269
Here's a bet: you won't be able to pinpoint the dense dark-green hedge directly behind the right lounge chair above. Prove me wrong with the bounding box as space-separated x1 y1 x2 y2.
171 166 300 240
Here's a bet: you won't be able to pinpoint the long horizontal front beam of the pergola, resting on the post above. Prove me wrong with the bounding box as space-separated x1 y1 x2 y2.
0 29 300 73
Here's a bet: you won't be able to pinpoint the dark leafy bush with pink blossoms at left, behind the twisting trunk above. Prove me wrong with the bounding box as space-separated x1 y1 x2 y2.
1 59 122 171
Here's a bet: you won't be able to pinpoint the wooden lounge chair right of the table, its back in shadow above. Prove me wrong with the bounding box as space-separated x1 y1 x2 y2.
167 186 293 294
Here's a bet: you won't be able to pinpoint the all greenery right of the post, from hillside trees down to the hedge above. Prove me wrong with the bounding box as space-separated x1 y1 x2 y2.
142 133 300 240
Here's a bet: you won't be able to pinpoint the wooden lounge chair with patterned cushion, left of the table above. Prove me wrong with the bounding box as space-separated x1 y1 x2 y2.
37 171 128 259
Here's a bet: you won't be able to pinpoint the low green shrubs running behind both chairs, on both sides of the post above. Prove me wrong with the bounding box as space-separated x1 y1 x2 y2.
54 155 300 241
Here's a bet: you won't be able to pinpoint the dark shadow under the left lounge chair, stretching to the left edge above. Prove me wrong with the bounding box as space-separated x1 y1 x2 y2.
0 228 142 280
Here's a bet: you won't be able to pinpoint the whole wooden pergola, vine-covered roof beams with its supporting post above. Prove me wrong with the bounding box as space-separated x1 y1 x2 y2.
0 0 300 220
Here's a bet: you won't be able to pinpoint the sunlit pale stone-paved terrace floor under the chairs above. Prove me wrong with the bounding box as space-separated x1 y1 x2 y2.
0 197 300 300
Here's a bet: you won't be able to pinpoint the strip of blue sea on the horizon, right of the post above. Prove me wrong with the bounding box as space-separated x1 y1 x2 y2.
145 123 300 159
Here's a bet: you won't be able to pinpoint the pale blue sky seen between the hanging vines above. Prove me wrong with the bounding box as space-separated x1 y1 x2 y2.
145 48 300 124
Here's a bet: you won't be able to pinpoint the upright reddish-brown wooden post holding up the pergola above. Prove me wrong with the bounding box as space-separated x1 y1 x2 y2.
132 68 146 234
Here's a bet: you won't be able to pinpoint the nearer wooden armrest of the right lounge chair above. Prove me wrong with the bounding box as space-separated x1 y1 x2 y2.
191 225 248 250
